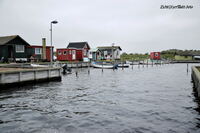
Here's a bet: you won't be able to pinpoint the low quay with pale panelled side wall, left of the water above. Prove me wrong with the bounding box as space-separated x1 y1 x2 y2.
0 65 61 89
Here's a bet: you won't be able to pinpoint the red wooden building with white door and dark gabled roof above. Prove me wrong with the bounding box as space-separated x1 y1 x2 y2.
56 42 90 61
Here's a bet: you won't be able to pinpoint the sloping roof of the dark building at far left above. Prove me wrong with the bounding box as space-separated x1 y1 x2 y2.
0 35 30 45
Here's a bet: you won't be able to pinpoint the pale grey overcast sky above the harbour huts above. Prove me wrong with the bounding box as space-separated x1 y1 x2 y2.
0 0 200 53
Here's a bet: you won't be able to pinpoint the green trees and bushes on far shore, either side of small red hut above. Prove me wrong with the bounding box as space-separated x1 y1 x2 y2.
121 49 200 60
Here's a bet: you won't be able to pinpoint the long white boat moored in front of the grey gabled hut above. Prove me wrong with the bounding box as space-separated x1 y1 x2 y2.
91 62 118 69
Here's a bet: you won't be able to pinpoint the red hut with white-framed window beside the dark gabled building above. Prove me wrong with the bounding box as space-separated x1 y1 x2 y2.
30 45 53 61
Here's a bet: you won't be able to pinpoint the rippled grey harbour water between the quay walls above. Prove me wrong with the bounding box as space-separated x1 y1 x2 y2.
0 64 200 133
